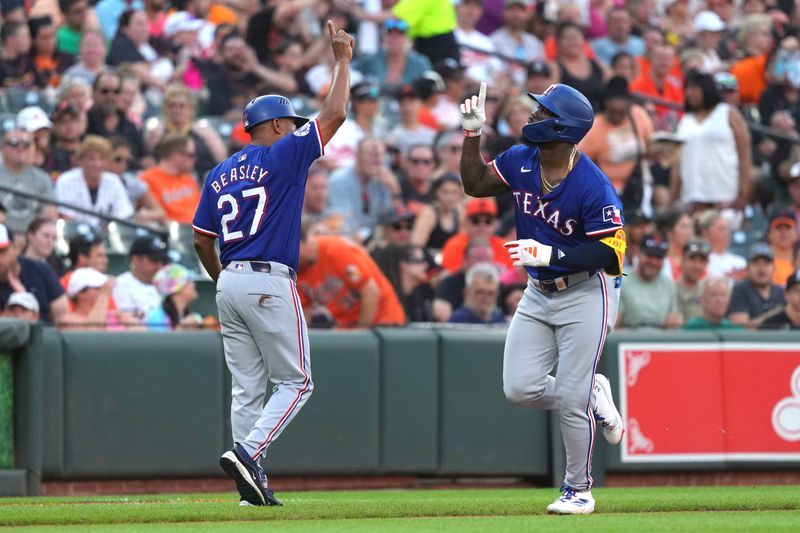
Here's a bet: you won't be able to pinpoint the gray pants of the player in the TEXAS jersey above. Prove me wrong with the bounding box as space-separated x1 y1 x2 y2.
503 274 619 490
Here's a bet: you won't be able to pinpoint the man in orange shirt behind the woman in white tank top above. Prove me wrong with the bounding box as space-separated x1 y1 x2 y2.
630 43 683 131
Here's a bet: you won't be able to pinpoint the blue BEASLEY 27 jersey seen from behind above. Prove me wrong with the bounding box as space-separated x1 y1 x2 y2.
192 115 323 269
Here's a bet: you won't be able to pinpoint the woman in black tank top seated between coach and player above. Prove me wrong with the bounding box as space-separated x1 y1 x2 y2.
411 172 464 250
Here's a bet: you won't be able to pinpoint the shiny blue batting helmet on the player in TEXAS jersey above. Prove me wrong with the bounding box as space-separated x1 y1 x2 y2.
522 83 594 144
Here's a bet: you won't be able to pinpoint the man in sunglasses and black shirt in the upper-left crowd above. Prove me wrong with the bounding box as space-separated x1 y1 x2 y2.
87 71 147 167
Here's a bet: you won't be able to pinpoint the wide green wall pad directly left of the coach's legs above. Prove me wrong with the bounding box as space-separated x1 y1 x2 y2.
62 332 228 478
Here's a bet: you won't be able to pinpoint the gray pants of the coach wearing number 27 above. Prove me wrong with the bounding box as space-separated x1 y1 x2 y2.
217 261 314 457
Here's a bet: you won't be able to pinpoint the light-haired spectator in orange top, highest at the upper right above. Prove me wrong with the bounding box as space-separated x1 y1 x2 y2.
731 13 772 104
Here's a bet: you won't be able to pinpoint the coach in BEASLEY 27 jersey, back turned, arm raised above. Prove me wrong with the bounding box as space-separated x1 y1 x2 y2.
193 21 353 505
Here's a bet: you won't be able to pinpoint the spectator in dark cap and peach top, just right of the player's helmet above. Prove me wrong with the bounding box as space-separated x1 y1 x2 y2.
578 77 654 195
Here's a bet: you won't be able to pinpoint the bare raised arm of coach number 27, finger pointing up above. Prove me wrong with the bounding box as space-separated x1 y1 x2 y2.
317 20 355 142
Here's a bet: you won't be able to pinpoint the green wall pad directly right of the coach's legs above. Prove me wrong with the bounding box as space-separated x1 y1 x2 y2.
265 331 380 475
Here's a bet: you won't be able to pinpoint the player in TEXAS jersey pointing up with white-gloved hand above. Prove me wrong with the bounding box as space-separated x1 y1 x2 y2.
461 83 625 514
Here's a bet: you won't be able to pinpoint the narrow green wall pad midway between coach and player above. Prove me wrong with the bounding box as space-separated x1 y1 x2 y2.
376 328 439 474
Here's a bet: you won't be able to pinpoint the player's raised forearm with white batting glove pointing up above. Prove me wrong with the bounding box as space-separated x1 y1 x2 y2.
461 83 508 198
